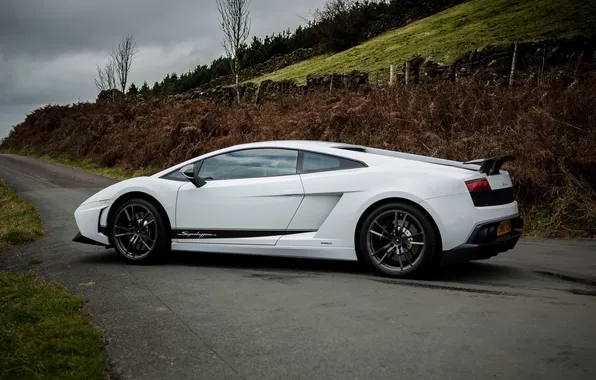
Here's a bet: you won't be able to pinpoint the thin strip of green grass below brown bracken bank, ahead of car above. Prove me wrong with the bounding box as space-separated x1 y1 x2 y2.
0 149 155 180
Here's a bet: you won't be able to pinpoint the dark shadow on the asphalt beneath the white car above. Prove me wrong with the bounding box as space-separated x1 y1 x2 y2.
80 249 523 284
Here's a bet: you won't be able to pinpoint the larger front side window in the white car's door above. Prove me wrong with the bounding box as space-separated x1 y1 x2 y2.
199 148 298 181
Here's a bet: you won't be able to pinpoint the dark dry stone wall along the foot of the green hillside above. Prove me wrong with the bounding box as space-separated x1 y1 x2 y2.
165 38 596 105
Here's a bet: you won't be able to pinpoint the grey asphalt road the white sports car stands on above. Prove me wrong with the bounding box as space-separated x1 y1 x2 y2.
0 155 596 380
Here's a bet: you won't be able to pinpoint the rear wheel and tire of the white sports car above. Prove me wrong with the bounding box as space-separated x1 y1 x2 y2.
357 202 439 278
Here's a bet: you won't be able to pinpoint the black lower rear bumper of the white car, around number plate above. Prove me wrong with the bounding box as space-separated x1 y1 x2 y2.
441 217 523 265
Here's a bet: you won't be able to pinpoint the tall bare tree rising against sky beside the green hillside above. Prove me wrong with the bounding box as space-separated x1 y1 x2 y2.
216 0 250 104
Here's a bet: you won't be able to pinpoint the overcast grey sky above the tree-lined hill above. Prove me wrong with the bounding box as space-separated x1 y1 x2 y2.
0 0 324 139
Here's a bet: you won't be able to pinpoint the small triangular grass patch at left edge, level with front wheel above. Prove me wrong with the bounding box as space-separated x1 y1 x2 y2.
0 181 44 252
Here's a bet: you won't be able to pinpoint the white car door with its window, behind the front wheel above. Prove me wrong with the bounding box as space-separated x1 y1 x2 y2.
175 148 304 245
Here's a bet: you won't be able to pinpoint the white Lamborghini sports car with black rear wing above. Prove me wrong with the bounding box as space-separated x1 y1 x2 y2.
73 141 523 277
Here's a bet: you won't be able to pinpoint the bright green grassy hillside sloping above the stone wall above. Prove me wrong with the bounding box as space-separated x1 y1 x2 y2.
252 0 596 82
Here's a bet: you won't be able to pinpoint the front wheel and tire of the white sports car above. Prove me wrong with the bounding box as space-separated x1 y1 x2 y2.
109 198 170 264
